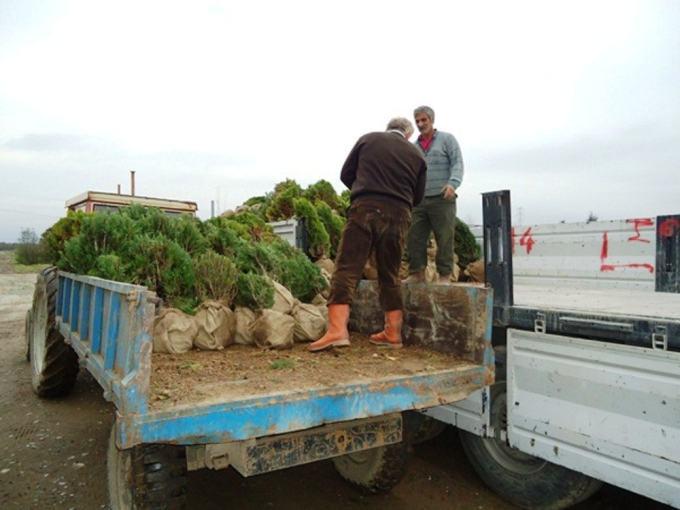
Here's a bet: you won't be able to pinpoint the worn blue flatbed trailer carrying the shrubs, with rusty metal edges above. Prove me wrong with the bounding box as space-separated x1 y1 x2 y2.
27 268 494 508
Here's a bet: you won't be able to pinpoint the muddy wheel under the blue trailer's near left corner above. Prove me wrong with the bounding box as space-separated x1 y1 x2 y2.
107 425 187 510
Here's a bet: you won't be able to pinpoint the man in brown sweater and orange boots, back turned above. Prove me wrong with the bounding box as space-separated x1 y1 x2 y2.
309 118 427 351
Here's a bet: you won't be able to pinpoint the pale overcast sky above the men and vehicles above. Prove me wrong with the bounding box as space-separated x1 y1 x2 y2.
0 0 680 241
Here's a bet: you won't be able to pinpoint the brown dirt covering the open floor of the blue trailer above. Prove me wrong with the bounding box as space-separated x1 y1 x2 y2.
150 333 472 410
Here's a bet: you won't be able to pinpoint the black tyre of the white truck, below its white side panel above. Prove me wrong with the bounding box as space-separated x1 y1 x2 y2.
459 382 602 510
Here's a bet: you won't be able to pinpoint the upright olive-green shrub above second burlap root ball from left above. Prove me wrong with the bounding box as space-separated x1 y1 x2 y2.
194 251 238 305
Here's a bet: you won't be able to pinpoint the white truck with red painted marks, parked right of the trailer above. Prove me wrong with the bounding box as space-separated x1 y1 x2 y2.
425 191 680 509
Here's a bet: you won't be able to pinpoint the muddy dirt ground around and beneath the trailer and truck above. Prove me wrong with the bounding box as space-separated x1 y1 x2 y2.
0 254 668 510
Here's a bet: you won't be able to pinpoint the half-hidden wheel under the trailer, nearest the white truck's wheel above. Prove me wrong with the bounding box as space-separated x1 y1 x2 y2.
333 441 408 494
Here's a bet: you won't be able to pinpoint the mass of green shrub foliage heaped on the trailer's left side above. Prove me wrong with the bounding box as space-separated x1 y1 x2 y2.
43 201 324 313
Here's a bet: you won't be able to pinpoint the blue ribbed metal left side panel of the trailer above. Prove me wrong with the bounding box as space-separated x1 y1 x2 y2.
56 271 154 414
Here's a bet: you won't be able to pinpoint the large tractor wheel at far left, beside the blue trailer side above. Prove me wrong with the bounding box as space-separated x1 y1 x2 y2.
27 267 78 397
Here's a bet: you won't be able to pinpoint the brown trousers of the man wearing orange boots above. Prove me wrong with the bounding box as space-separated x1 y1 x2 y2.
328 197 411 311
